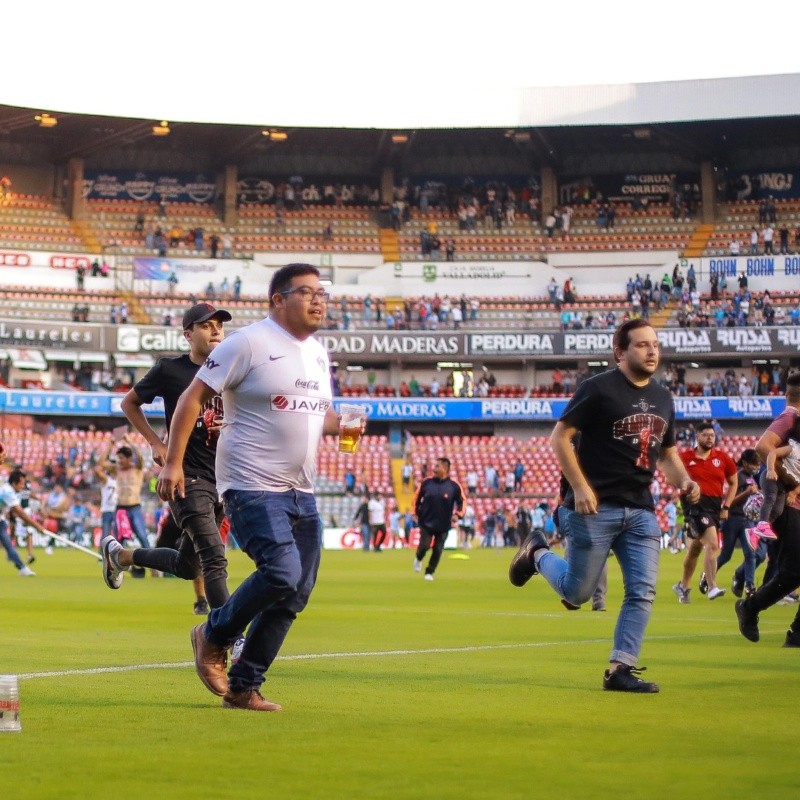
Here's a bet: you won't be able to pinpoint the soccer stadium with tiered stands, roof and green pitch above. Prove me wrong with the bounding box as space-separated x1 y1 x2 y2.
0 12 800 800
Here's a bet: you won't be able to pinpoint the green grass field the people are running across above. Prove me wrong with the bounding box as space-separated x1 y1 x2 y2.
0 550 800 800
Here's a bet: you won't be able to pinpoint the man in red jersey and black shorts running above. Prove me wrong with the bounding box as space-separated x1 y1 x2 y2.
672 422 736 603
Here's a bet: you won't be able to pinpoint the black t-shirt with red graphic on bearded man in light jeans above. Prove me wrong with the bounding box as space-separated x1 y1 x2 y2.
561 369 675 509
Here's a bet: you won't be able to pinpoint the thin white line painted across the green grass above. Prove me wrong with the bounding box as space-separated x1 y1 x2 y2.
17 631 760 680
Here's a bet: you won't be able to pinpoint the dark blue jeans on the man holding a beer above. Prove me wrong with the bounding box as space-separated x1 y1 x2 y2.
205 489 322 692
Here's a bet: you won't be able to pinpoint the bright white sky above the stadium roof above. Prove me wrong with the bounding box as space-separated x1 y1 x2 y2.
6 0 800 128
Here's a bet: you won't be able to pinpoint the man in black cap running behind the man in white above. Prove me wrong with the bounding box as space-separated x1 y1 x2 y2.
101 303 231 614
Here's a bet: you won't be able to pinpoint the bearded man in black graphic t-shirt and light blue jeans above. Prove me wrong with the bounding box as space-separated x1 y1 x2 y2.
509 319 700 692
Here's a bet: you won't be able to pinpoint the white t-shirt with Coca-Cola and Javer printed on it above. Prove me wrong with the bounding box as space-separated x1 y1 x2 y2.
197 318 331 494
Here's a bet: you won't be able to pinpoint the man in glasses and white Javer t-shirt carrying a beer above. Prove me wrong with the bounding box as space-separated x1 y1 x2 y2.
158 264 339 711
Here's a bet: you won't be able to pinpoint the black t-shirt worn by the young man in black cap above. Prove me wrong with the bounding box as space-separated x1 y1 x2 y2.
133 354 222 483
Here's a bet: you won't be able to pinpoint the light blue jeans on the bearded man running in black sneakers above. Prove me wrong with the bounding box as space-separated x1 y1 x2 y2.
538 504 661 666
